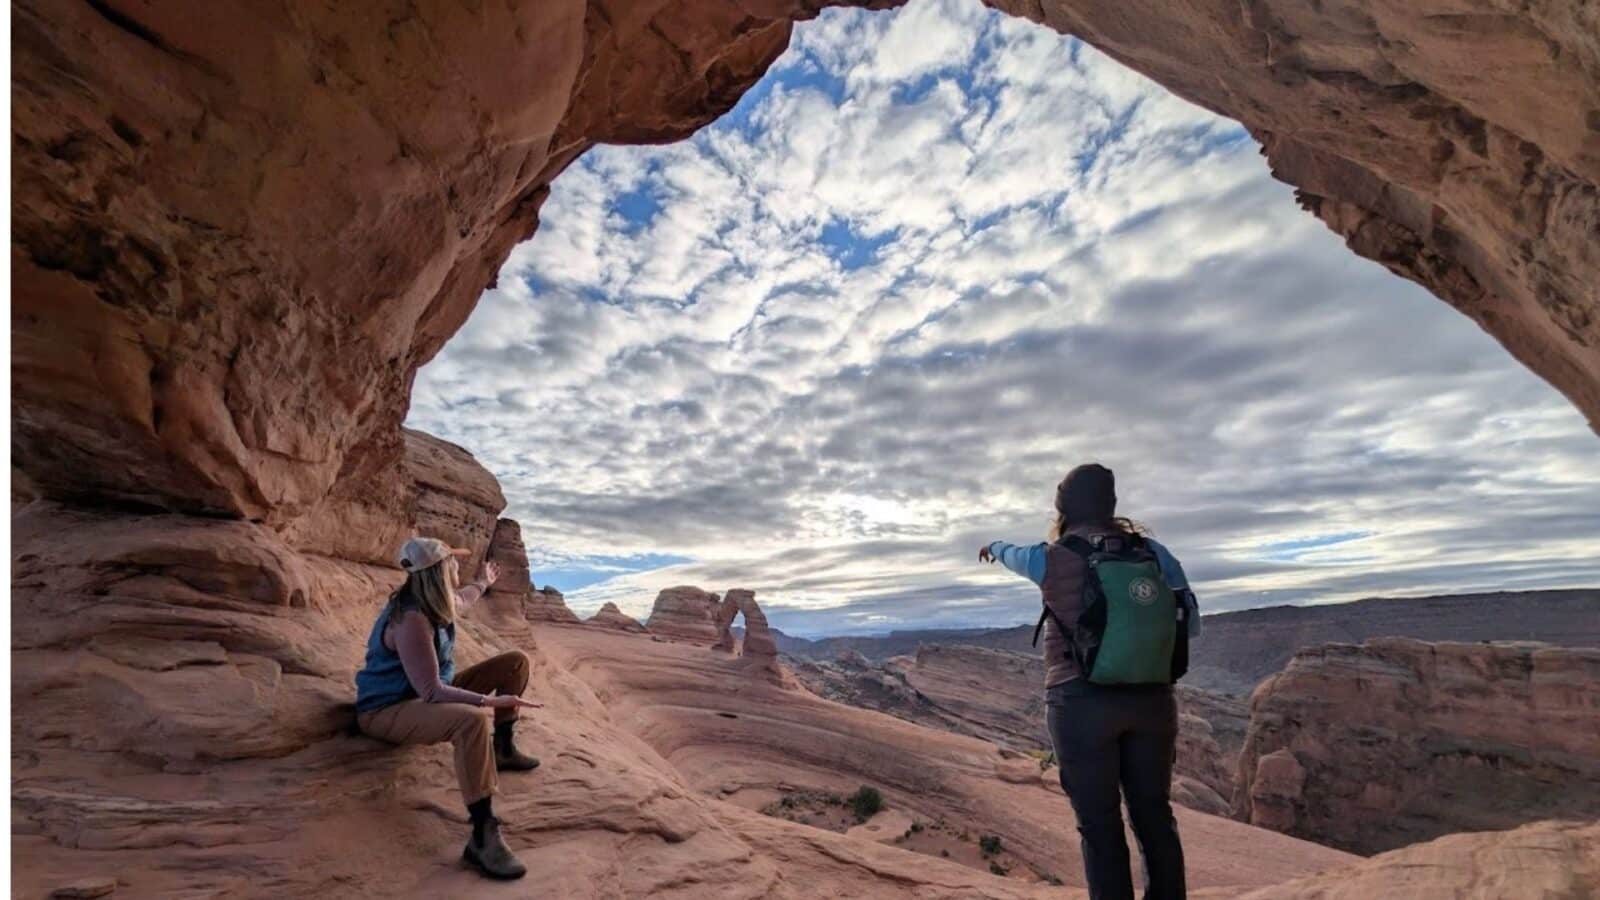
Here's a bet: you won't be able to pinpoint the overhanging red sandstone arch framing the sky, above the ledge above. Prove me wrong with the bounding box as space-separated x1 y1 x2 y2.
13 0 1600 531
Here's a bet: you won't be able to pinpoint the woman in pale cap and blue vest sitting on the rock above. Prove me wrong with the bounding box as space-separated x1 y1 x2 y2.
355 538 539 879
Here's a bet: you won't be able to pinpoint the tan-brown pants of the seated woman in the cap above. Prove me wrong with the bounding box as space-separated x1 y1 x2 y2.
355 650 528 804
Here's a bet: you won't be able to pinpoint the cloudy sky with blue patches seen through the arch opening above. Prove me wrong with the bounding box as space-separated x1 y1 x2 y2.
410 0 1600 636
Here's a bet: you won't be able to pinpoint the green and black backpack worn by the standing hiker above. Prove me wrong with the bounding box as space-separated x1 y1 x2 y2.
1034 535 1189 684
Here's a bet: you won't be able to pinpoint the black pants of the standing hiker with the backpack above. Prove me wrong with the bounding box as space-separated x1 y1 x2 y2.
1045 679 1186 900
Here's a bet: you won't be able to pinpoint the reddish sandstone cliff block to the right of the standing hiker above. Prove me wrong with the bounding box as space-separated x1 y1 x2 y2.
1235 639 1600 854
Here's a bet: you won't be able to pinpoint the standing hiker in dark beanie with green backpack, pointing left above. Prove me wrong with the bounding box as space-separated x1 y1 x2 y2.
978 463 1198 900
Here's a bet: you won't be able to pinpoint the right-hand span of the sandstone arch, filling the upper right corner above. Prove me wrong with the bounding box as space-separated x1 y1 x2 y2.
990 0 1600 429
